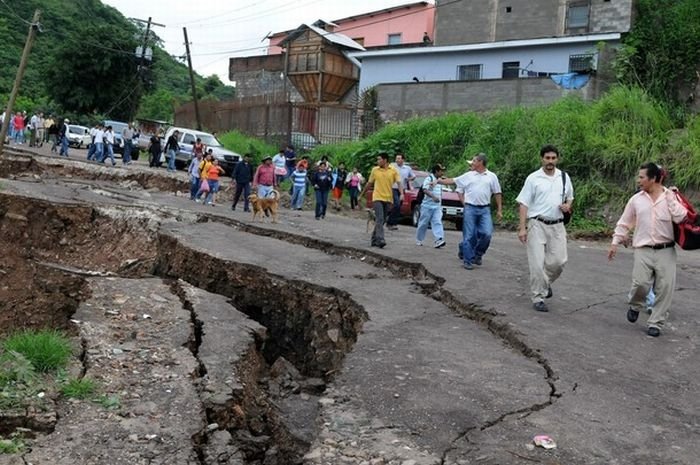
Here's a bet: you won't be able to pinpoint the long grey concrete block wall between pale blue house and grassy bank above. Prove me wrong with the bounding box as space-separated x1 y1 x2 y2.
377 77 600 121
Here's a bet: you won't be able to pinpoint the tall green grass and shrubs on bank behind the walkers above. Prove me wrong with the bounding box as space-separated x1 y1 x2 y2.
314 87 700 230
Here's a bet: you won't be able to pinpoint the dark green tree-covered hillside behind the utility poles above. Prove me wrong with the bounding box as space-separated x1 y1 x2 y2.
0 0 234 121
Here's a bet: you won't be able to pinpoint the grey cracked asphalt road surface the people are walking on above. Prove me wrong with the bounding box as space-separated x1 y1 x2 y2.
3 150 700 465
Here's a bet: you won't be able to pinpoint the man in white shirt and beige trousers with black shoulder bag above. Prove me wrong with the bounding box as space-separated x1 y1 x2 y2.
516 145 574 312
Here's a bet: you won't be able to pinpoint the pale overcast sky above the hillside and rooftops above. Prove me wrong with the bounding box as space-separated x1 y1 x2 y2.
102 0 422 84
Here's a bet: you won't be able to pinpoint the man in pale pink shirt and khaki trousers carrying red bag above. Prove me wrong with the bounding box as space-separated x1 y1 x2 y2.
608 163 688 337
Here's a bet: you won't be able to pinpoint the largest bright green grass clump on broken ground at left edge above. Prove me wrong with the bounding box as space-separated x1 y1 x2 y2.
2 330 72 373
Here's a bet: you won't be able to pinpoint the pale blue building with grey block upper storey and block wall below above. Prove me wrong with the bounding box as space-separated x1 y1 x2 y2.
351 0 633 119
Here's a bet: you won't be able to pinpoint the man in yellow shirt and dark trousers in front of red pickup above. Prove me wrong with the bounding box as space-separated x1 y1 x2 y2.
366 153 403 249
